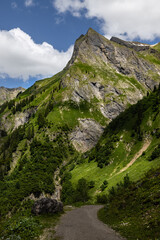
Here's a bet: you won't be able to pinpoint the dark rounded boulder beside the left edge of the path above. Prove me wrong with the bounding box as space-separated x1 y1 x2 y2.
31 198 63 215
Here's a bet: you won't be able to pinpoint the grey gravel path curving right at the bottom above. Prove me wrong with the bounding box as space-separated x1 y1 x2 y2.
55 205 123 240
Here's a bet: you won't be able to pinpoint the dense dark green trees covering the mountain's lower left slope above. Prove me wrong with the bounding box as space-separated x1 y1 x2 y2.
0 135 72 215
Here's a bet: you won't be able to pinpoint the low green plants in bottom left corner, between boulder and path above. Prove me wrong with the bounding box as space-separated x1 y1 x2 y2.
0 200 60 240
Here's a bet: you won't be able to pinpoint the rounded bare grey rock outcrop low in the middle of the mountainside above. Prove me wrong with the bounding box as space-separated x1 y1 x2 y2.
69 119 104 153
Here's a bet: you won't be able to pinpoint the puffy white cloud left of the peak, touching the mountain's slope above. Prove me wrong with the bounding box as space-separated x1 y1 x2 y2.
0 28 73 81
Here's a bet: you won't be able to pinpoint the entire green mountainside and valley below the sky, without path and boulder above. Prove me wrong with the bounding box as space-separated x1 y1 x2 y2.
0 29 160 240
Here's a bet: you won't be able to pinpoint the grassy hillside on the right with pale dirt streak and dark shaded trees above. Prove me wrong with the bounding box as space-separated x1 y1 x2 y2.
62 86 160 201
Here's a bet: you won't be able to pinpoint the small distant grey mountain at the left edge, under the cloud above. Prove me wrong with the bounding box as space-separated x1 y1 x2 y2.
0 87 25 105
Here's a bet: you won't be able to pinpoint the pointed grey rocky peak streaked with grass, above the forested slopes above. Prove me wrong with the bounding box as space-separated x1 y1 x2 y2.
2 29 160 152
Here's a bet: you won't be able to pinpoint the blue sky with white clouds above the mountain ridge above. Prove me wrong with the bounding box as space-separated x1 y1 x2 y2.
0 0 160 88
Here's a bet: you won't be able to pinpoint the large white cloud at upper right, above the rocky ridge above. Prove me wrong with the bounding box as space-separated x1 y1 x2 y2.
53 0 160 40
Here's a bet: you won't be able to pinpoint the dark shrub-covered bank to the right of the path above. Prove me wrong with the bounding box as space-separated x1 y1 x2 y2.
98 168 160 240
